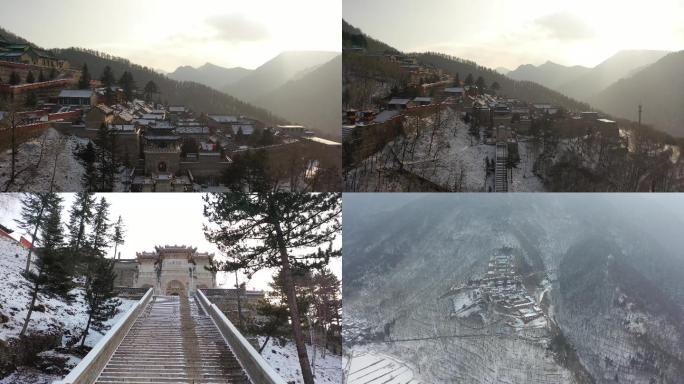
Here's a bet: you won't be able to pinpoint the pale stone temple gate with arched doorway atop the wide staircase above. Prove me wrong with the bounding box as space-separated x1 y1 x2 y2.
114 245 216 295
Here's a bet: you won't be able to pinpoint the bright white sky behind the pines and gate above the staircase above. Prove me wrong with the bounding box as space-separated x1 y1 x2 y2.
0 193 342 289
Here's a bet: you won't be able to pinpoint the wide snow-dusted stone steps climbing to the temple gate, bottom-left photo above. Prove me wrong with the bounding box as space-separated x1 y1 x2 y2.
96 296 250 384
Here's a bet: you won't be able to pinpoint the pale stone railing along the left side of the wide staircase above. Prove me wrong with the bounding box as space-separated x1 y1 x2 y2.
53 288 152 384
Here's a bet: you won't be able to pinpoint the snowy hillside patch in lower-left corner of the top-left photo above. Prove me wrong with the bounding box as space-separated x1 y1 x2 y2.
0 128 88 192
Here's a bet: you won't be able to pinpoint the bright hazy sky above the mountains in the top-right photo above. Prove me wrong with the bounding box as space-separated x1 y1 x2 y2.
342 0 684 69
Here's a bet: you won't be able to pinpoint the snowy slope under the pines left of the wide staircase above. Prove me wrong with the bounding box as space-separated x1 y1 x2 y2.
0 237 137 384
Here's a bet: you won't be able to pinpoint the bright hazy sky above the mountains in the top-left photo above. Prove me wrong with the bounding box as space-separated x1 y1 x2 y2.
0 0 342 71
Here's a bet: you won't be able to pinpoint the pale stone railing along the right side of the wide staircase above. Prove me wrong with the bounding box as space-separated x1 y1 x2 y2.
197 290 287 384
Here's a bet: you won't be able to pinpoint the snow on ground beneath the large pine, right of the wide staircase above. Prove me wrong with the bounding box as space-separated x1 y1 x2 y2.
259 337 342 384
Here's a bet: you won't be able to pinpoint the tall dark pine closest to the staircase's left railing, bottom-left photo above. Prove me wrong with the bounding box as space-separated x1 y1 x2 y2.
81 197 119 346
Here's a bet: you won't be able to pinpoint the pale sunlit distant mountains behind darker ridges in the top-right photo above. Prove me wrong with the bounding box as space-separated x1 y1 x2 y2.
508 50 668 101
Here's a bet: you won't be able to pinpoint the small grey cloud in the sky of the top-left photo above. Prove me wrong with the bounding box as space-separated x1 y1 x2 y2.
206 14 270 43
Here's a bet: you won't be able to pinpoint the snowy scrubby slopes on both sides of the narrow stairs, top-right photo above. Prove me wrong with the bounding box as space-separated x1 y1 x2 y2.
347 108 544 192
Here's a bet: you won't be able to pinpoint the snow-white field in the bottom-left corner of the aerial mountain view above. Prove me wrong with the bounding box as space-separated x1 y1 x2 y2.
344 347 422 384
